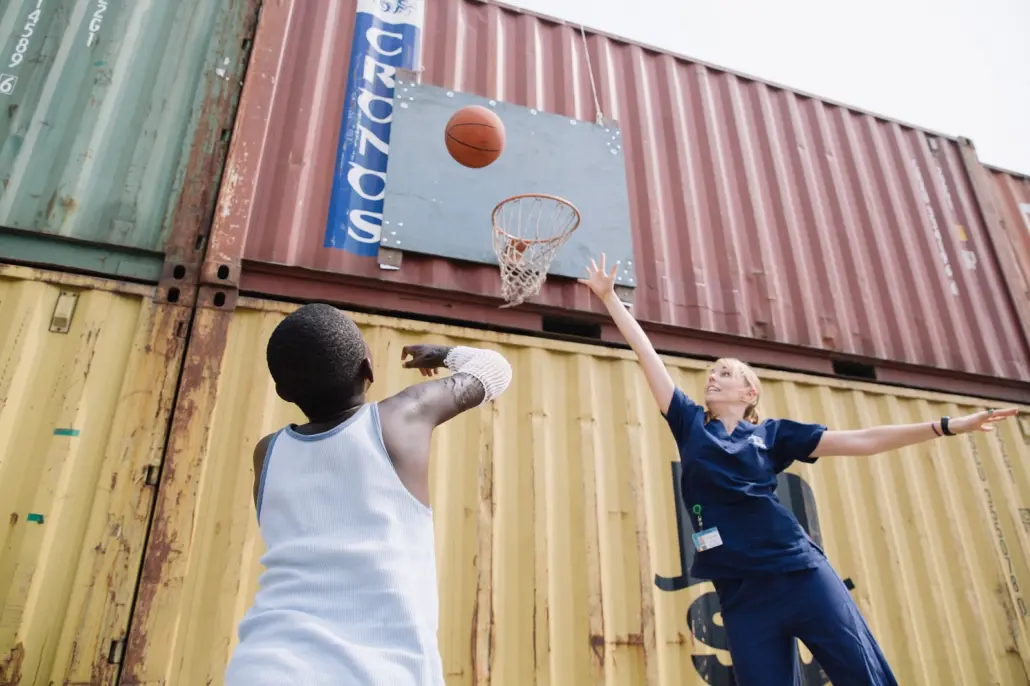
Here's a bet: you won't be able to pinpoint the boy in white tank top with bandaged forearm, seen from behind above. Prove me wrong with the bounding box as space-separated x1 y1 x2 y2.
226 305 512 686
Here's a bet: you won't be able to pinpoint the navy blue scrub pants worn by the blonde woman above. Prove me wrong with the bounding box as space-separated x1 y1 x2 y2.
716 560 897 686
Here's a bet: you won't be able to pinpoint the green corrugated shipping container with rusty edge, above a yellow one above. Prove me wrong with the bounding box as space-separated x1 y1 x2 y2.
0 0 261 282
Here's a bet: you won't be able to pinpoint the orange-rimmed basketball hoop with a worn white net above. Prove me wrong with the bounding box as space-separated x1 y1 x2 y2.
490 193 580 307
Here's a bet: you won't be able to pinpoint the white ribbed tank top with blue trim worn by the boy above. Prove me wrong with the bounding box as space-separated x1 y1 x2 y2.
226 404 444 686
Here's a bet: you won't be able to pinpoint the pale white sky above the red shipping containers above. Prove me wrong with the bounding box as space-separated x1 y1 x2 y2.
506 0 1030 174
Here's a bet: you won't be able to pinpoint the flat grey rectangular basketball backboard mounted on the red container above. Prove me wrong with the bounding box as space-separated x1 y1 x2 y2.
381 72 637 287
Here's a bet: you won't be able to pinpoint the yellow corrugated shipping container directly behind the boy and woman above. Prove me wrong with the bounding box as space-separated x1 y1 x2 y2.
121 299 1030 686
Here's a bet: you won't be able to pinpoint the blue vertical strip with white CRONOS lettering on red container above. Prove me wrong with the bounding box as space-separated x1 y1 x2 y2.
324 0 425 256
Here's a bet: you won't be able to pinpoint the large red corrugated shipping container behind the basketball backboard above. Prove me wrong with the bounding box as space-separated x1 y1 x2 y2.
202 0 1030 400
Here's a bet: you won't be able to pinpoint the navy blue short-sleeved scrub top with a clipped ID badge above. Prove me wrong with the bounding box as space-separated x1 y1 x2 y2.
665 388 826 579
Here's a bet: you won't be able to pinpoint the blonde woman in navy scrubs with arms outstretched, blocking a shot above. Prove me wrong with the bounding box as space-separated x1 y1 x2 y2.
581 255 1017 686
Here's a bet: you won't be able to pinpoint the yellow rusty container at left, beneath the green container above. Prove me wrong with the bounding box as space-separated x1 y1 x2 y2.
0 266 190 686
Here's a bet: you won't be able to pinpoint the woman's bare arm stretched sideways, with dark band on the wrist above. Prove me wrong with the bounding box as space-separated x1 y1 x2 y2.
812 408 1019 457
